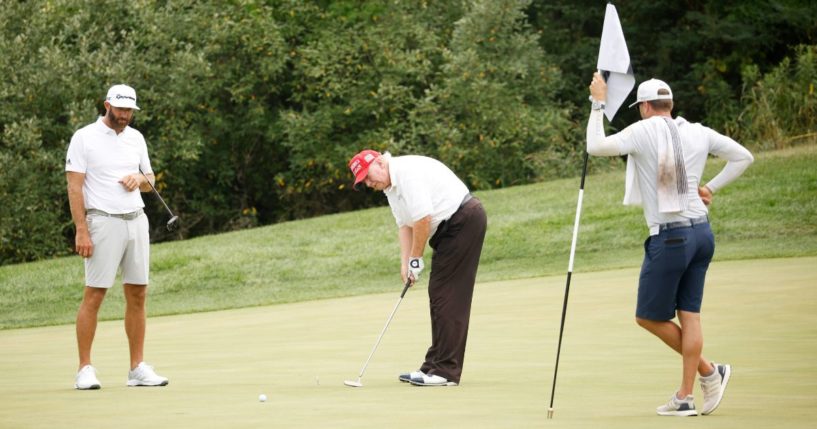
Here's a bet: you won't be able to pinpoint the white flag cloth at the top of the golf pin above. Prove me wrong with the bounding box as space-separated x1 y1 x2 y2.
596 4 635 121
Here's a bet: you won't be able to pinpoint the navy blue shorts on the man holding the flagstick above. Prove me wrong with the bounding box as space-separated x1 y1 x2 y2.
635 223 715 321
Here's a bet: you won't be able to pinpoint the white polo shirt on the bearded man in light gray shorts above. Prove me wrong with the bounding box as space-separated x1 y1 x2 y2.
65 117 153 214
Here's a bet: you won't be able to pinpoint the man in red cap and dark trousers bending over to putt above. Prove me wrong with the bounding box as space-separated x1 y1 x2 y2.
349 150 487 386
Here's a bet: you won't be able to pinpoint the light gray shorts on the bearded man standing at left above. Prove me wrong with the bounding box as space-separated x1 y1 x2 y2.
85 213 150 289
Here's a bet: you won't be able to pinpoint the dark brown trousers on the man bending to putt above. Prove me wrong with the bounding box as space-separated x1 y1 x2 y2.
420 198 487 383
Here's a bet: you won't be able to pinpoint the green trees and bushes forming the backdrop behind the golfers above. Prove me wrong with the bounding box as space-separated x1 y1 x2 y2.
0 0 817 264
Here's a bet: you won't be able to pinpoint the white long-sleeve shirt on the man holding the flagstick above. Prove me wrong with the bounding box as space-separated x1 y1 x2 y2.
587 110 754 235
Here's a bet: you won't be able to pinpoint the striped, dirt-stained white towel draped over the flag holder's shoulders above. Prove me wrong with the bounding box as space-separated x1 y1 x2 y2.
624 117 689 213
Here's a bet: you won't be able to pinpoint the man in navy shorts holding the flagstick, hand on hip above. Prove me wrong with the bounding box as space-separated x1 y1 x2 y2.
587 73 753 416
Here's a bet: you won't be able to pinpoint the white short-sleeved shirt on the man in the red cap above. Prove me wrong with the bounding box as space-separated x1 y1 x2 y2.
383 154 469 236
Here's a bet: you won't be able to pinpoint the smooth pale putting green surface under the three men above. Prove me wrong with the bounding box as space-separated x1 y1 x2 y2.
0 257 817 429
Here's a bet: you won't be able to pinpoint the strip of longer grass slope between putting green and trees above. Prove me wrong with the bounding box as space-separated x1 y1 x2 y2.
0 145 817 329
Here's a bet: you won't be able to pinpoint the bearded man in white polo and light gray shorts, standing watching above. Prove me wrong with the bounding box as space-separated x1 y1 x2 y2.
65 85 168 390
